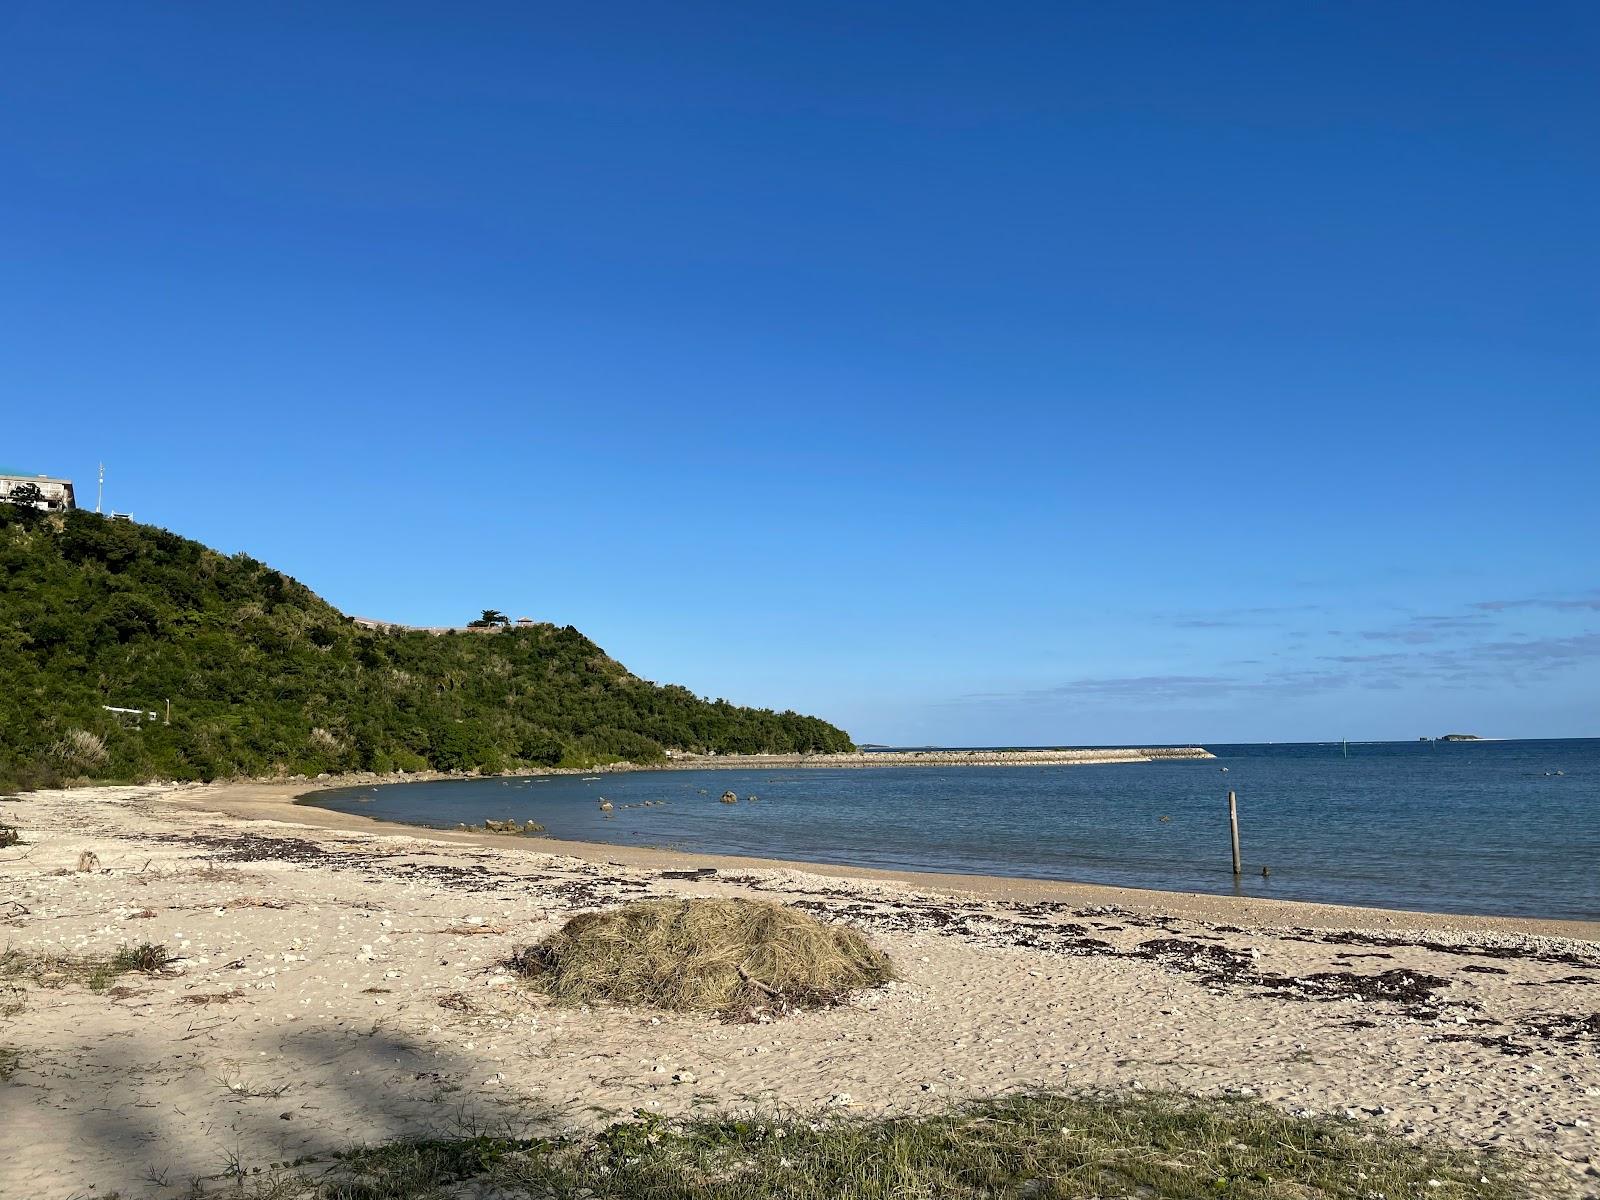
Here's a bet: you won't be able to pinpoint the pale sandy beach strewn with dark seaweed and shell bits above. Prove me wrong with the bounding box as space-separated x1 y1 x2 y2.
0 784 1600 1197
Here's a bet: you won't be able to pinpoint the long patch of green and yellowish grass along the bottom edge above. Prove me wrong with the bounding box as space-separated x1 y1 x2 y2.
219 1093 1526 1200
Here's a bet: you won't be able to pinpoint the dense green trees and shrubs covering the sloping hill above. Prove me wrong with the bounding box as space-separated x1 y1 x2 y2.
0 504 850 786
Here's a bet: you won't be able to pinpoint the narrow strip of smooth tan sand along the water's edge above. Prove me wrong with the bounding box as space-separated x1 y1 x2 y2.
178 778 1600 942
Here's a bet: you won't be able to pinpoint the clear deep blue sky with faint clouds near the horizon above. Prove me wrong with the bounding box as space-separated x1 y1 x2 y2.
0 0 1600 744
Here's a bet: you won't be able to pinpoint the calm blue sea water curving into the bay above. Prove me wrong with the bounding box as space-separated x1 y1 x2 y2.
314 739 1600 918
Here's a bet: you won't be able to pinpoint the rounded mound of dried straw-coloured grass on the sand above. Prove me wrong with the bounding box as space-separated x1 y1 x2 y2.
512 899 894 1019
